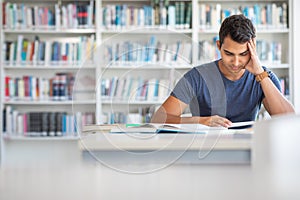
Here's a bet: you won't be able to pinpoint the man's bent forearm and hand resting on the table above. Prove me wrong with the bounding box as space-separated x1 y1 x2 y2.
151 96 231 127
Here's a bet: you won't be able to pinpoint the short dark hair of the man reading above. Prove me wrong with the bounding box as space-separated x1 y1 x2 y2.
219 14 256 46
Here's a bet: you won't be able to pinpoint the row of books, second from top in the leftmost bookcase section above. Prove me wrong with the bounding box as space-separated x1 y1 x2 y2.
2 35 95 65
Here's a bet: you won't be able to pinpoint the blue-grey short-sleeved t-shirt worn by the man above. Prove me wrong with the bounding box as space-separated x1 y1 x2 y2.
171 60 281 122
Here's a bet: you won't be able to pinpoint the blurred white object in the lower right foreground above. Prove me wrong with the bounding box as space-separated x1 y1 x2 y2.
252 115 300 199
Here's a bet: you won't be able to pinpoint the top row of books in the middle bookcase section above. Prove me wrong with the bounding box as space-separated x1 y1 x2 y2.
102 1 192 29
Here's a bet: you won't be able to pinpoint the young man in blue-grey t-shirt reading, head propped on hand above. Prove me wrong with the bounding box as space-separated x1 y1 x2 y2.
152 15 295 127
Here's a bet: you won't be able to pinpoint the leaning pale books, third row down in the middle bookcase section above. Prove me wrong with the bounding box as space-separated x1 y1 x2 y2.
100 77 172 102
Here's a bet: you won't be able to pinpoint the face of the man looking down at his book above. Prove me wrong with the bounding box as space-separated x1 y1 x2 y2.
217 36 250 74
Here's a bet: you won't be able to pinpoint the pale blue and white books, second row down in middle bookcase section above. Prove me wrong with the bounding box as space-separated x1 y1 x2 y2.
104 36 192 64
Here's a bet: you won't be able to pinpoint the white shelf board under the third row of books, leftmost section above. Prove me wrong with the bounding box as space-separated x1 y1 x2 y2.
4 100 96 106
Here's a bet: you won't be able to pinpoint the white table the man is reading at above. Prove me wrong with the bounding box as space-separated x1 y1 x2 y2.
80 130 252 171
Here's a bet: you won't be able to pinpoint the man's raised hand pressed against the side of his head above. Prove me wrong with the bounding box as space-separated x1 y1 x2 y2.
245 38 264 76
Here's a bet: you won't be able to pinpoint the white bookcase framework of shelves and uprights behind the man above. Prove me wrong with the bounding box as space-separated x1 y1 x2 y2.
0 0 300 144
